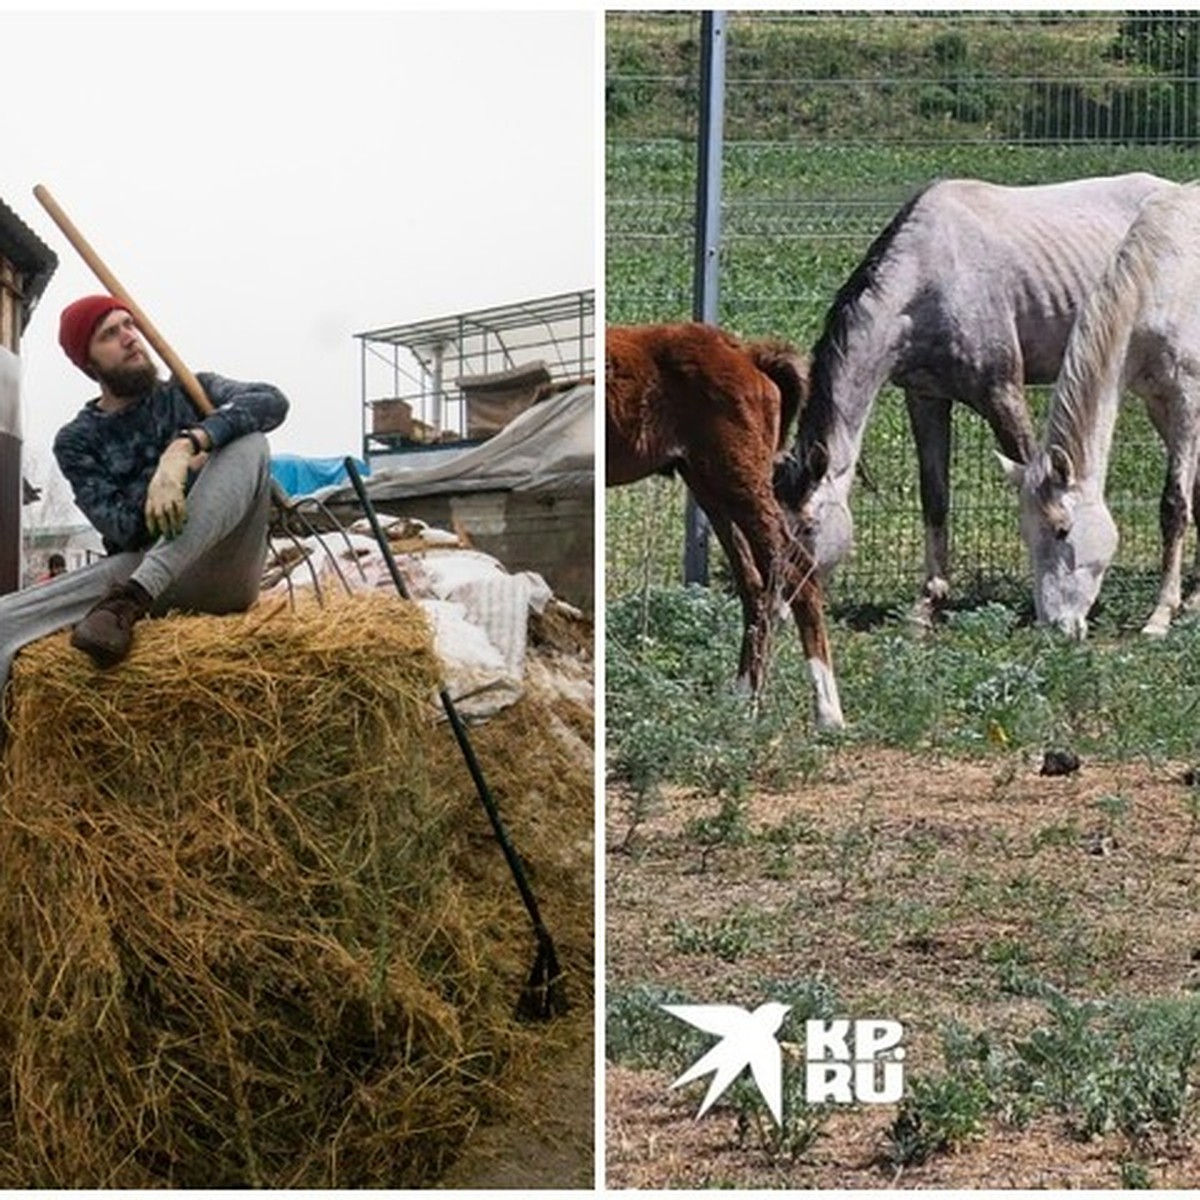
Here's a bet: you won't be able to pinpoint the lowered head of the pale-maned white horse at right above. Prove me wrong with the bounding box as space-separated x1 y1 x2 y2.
1001 445 1117 638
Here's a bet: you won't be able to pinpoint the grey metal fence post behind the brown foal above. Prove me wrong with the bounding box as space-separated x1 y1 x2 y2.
683 11 725 583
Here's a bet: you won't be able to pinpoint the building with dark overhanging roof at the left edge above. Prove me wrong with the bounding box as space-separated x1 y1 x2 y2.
0 200 59 595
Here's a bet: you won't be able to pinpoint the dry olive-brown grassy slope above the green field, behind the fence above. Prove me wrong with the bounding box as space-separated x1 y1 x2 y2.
606 12 1196 142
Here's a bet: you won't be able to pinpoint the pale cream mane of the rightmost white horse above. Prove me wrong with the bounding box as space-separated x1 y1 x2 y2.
1045 192 1170 474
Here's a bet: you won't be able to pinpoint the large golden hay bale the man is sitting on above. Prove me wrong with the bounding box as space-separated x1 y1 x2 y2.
0 594 592 1188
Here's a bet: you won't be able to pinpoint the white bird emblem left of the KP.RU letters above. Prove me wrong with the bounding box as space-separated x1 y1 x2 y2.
660 1002 791 1126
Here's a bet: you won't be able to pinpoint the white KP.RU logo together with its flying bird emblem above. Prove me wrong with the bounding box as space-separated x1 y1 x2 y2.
662 1002 905 1124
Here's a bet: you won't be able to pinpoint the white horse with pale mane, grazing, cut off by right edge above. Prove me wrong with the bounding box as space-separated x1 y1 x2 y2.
1004 184 1200 637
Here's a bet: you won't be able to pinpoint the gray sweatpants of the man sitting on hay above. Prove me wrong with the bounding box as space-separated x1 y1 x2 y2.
0 433 271 696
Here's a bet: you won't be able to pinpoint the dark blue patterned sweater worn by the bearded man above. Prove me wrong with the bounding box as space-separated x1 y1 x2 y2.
54 373 288 554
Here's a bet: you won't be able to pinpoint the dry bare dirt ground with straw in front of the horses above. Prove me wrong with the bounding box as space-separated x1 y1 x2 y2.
605 748 1200 1189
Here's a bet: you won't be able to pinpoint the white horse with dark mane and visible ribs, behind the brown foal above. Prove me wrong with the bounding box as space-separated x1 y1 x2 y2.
775 174 1177 620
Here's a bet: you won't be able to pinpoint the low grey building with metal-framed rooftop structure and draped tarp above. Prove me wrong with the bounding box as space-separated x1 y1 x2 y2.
340 290 595 612
